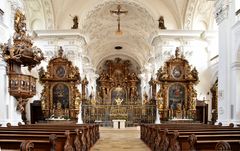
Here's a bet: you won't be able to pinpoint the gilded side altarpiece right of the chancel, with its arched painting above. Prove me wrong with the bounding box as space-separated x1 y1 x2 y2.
155 48 199 120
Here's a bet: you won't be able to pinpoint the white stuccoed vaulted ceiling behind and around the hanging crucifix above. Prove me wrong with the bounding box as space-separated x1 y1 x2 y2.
23 0 214 72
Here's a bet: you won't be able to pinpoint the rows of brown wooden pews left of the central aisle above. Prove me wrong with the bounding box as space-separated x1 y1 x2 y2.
0 124 99 150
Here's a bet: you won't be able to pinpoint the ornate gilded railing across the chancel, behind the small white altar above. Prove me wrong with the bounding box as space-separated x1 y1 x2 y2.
82 105 156 126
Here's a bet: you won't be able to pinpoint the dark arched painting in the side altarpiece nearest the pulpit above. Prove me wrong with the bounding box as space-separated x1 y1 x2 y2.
52 83 69 109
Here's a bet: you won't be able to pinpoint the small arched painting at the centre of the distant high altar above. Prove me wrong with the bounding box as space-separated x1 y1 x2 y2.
111 86 126 105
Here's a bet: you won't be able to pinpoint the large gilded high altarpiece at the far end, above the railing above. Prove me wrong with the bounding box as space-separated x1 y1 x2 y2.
98 58 140 104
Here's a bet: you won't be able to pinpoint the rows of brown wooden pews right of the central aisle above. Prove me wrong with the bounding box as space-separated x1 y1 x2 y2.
141 124 240 150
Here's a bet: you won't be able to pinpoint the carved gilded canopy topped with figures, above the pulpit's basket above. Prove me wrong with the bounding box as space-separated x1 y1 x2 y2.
0 10 44 70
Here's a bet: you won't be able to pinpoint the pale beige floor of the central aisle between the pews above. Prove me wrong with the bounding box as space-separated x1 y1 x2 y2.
91 127 150 151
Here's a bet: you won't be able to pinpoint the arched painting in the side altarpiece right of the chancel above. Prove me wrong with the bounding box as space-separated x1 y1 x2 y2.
168 83 185 110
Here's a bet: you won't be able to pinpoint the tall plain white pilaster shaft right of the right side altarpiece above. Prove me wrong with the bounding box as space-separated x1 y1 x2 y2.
217 14 231 125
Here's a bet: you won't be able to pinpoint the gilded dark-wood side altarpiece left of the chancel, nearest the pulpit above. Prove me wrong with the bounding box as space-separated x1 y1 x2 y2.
39 47 82 119
